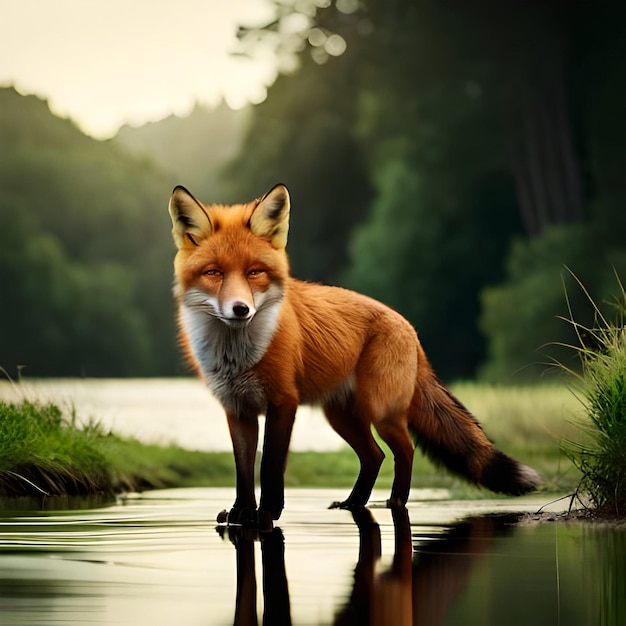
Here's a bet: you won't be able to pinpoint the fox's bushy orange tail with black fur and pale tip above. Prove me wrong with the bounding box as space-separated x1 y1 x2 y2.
409 371 541 496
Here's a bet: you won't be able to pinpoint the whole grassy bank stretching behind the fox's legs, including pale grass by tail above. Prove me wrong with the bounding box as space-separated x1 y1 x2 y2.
0 383 580 497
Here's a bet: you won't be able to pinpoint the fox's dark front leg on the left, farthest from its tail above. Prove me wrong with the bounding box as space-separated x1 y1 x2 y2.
217 412 259 526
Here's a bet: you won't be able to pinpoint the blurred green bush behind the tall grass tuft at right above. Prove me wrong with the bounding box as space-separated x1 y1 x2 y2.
480 224 626 382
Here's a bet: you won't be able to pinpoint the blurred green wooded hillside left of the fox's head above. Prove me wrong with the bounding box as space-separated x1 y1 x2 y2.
0 89 179 376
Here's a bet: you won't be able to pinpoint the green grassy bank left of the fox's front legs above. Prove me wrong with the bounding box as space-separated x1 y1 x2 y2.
0 400 234 497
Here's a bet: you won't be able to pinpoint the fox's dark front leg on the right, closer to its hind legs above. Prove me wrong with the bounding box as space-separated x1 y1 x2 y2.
259 402 298 524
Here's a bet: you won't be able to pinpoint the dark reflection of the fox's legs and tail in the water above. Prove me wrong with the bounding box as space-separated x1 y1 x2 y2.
217 507 518 626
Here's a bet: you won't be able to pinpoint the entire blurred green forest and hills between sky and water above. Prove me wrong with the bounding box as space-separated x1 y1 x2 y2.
0 0 626 382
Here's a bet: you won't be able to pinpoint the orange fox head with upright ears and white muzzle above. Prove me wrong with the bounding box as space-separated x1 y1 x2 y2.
169 184 290 327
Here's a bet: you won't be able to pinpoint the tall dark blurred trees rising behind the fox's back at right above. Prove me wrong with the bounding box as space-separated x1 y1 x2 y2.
223 0 626 380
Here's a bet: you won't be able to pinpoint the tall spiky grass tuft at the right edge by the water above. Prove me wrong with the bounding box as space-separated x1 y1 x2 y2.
564 274 626 516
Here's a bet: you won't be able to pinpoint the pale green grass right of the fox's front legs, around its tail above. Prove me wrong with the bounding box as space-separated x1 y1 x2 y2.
285 382 581 498
